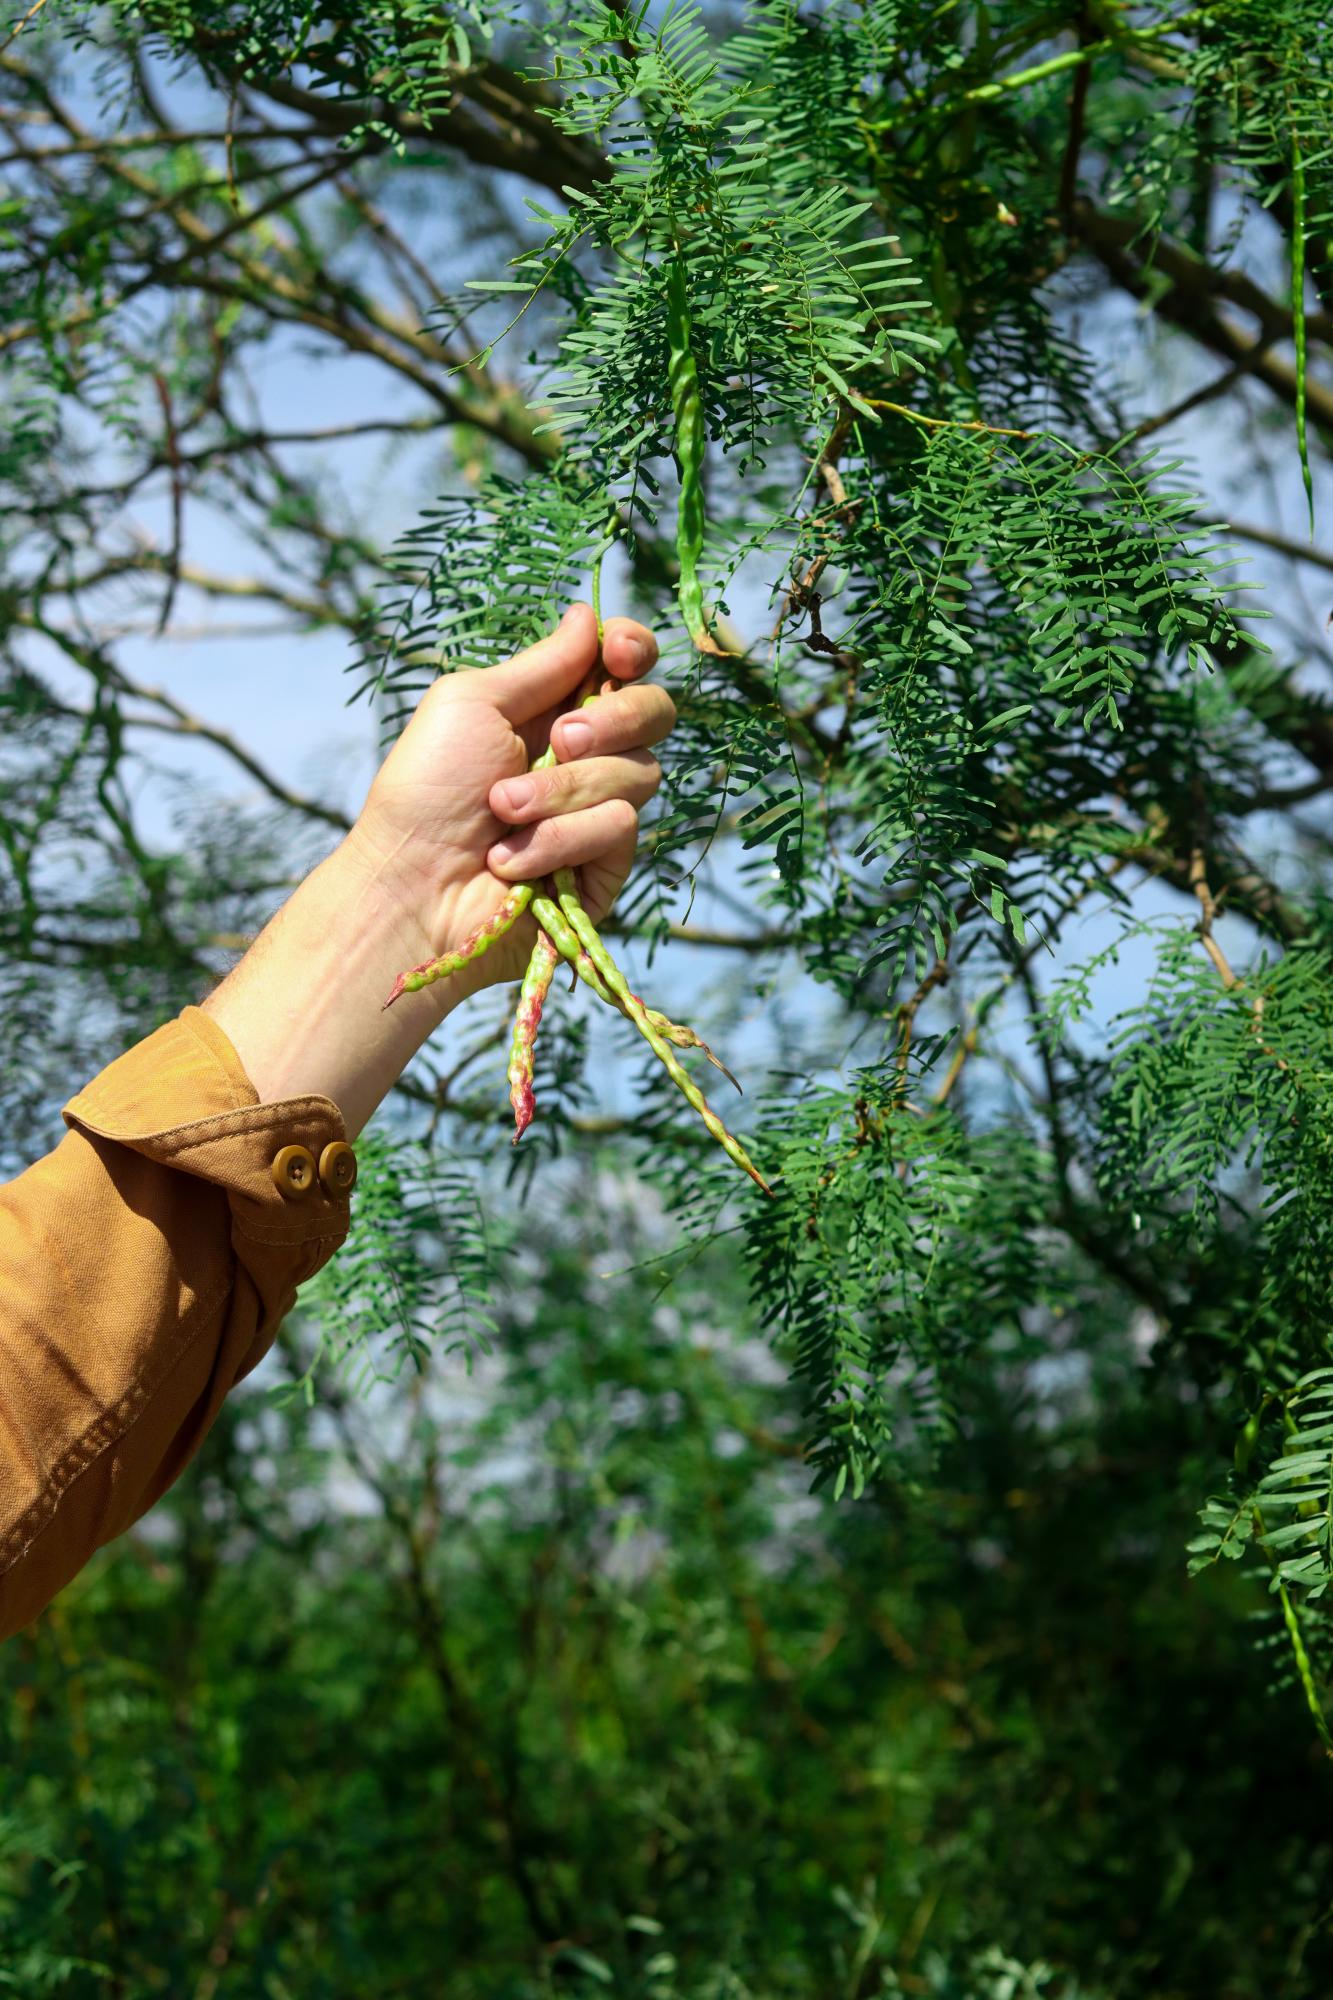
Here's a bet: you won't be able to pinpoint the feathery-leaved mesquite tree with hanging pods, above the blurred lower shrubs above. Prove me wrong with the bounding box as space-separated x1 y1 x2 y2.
0 0 1333 1742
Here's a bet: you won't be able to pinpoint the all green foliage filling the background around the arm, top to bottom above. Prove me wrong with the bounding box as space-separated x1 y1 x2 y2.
0 0 1333 2000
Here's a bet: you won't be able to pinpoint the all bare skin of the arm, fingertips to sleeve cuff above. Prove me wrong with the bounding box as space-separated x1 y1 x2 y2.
202 604 675 1138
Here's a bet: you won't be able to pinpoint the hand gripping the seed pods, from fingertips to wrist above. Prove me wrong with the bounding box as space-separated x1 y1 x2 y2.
346 604 675 1004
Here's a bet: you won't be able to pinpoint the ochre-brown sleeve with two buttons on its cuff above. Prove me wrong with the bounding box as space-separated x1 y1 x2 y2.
0 1006 350 1638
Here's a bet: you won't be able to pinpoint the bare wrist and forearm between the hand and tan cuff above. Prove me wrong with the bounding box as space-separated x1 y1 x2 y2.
200 840 456 1140
